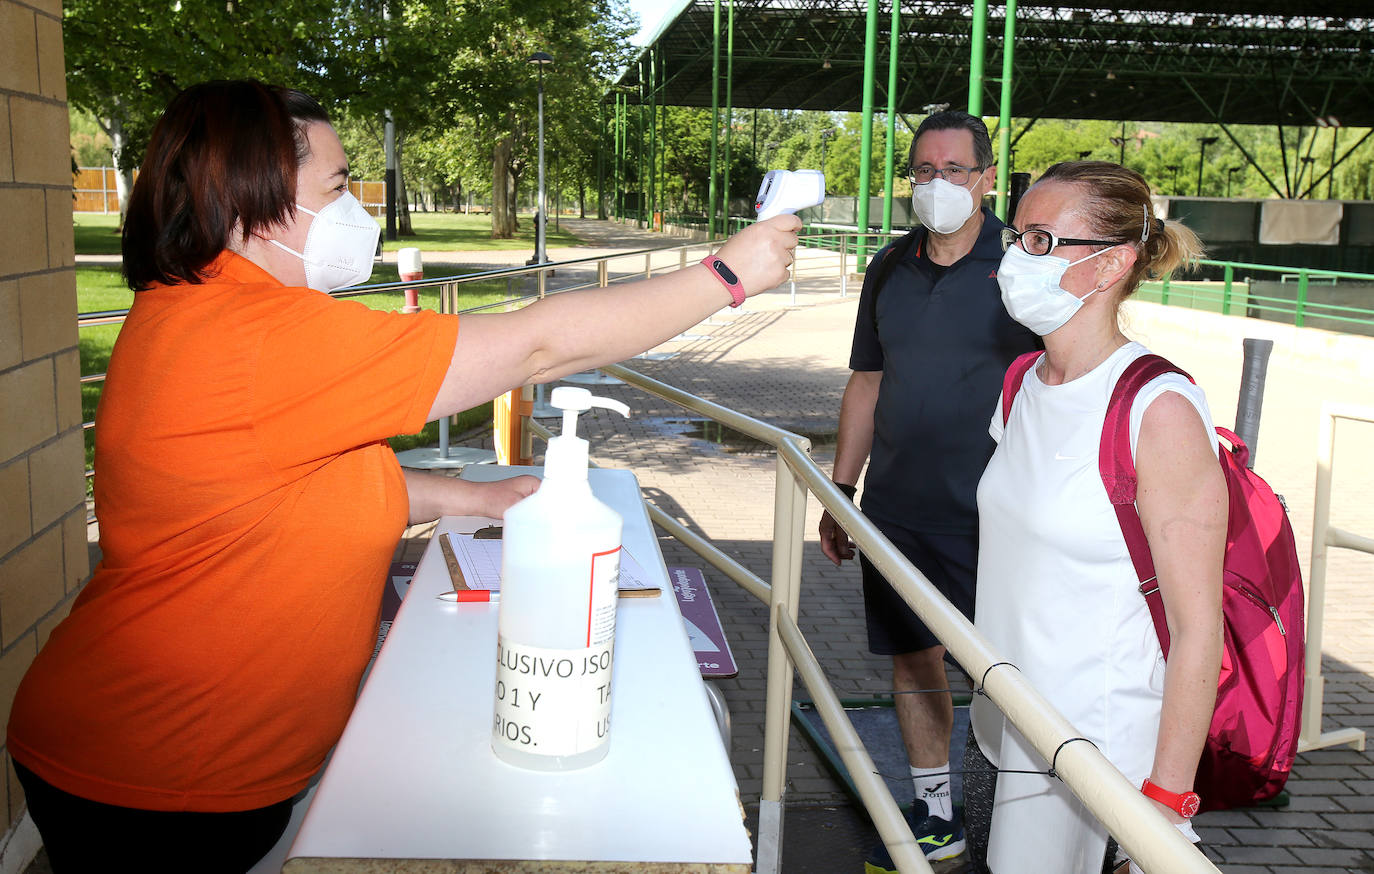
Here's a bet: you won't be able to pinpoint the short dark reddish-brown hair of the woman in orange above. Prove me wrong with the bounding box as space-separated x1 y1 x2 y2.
122 80 330 291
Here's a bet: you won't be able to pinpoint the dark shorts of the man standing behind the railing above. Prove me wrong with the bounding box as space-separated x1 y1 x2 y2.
859 519 978 656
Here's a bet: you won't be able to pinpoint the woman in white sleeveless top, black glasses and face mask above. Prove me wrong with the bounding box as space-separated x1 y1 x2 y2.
965 162 1227 874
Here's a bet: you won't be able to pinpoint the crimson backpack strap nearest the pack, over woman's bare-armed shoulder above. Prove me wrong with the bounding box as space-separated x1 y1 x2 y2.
1098 355 1193 658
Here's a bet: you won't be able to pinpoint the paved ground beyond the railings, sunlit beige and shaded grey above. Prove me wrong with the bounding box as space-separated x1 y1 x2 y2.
387 221 1374 874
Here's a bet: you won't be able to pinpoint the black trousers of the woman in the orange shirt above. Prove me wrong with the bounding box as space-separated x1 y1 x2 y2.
14 761 293 874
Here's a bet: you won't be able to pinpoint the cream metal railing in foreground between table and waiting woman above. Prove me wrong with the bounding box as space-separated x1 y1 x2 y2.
525 364 1217 874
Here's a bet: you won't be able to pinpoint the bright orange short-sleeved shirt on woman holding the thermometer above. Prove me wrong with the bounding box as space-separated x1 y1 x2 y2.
8 253 458 812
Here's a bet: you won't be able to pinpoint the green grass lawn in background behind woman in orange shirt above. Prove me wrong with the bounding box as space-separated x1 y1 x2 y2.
74 213 546 467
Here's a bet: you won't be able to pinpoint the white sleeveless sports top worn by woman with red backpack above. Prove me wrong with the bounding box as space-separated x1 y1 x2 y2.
971 342 1216 874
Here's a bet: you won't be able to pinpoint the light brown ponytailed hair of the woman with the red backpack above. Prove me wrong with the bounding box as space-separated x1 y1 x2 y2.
1036 161 1202 298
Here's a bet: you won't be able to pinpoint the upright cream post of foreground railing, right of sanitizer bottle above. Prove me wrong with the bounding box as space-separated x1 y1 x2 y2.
754 450 811 874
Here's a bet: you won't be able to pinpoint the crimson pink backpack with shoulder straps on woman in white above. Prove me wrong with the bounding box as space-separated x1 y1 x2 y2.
1002 352 1304 811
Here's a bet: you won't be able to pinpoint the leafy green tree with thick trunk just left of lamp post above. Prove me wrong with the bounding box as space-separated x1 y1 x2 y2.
326 0 631 236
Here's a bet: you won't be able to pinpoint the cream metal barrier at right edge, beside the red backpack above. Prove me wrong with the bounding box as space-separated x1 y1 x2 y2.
1298 403 1374 750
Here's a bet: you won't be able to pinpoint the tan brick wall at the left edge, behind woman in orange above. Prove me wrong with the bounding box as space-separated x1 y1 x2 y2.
0 0 89 831
